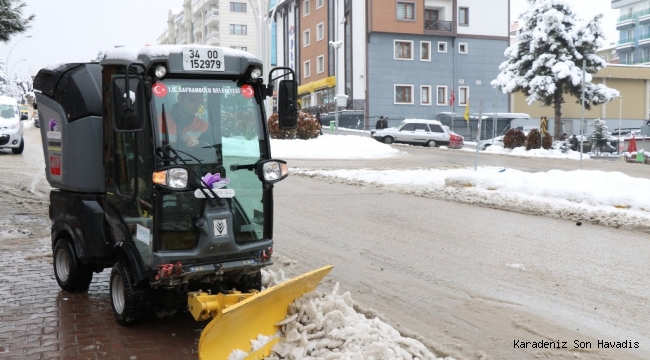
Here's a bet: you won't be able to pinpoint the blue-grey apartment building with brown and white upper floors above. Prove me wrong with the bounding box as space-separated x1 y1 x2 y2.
367 0 510 124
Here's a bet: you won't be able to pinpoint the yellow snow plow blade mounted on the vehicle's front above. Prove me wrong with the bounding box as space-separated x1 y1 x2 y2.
188 265 332 360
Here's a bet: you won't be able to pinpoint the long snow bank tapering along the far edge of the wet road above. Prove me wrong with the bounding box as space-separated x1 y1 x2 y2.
291 167 650 232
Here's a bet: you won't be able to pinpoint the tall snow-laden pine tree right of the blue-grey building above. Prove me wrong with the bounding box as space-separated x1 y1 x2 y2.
491 0 619 139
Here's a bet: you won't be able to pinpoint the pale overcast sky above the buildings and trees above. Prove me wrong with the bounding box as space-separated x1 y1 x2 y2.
0 0 618 80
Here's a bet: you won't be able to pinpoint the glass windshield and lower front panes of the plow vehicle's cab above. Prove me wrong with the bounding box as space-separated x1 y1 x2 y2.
152 78 269 251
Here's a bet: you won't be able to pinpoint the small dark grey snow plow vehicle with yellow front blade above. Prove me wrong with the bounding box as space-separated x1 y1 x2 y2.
34 45 331 359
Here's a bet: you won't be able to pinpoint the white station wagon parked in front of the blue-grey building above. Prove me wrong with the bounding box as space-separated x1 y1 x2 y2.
370 119 450 147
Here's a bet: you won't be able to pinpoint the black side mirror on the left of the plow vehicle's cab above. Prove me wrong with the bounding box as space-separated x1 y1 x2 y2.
113 76 146 131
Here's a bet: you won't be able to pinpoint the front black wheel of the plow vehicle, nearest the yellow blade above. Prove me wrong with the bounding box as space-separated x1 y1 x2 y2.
110 262 149 326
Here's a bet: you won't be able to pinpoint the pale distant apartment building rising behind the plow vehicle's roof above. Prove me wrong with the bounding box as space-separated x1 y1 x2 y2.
158 0 260 56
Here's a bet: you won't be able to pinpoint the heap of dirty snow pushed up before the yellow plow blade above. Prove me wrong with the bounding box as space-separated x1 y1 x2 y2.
267 283 451 360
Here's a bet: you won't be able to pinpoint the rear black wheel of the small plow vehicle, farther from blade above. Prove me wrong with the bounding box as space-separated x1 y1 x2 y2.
53 238 93 291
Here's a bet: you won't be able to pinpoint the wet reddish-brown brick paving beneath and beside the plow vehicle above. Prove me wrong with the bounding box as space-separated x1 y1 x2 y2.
0 251 207 360
